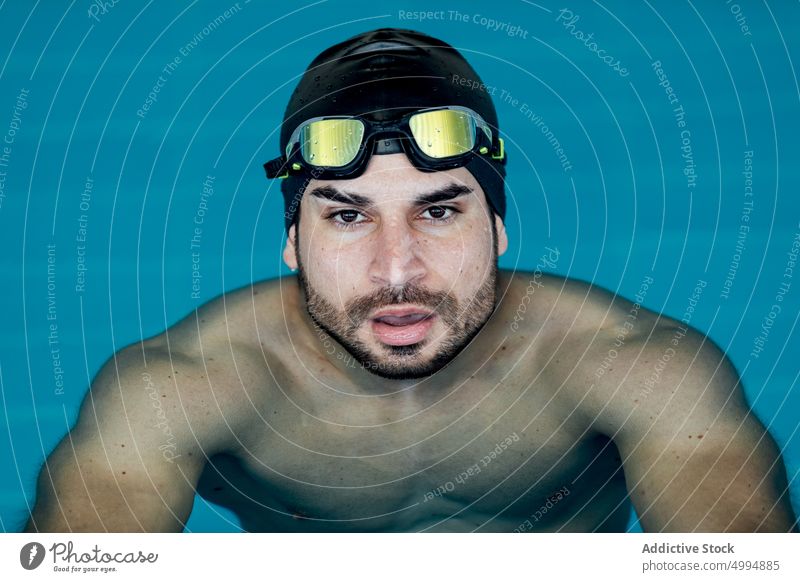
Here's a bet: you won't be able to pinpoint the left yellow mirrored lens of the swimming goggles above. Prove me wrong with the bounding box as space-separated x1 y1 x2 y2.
300 119 364 168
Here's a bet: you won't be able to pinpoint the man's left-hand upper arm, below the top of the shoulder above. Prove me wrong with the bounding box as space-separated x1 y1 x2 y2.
26 344 225 531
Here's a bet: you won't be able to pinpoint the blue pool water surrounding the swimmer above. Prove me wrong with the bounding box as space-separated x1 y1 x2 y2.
0 0 800 531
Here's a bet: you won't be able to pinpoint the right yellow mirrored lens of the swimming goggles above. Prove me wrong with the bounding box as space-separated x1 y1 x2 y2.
409 109 476 158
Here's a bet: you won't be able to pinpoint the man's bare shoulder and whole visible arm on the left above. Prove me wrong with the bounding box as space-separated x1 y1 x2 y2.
28 283 298 531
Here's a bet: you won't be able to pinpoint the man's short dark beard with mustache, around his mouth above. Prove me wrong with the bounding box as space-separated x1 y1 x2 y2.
297 253 499 380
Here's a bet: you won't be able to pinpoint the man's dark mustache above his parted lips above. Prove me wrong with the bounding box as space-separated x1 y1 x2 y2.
345 284 458 331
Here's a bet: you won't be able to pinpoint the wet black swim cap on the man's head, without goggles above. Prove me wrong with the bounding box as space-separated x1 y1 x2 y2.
281 28 506 230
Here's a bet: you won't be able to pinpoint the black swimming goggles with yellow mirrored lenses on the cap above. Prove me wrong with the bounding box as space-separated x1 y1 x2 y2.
264 106 505 180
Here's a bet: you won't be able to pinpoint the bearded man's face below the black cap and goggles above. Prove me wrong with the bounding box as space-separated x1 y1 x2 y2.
284 154 508 379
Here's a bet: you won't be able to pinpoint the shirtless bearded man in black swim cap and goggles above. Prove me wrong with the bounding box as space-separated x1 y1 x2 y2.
28 29 794 532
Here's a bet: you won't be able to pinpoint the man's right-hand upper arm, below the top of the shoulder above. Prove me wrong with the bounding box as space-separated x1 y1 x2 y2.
596 325 794 532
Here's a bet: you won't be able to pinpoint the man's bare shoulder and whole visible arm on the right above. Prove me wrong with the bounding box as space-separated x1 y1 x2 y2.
500 274 795 532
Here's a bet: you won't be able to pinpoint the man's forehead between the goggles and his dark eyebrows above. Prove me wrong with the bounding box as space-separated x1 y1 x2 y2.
303 153 485 204
